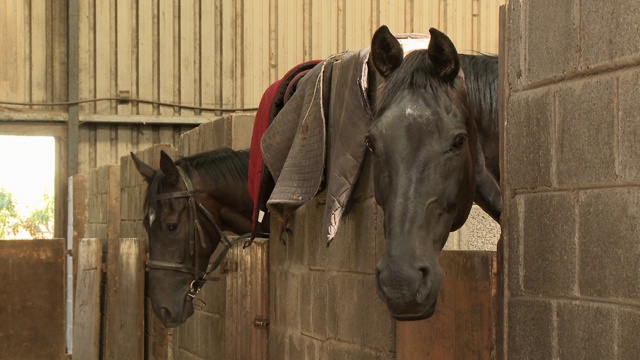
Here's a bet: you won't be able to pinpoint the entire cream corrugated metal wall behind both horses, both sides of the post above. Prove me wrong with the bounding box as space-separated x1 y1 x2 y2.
0 0 505 172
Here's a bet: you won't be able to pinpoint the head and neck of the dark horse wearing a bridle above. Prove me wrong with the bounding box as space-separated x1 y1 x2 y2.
131 149 264 327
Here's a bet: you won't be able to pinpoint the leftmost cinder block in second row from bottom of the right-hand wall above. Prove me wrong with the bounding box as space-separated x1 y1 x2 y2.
522 193 577 294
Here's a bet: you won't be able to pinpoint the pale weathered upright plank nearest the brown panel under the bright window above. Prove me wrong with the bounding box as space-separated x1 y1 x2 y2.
73 238 102 360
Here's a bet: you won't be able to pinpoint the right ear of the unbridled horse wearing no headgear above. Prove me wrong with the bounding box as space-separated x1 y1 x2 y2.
427 28 460 83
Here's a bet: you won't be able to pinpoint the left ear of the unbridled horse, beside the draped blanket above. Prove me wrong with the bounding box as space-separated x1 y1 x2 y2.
371 25 404 78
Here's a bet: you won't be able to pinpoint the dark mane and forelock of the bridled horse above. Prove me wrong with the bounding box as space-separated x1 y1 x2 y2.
144 148 249 215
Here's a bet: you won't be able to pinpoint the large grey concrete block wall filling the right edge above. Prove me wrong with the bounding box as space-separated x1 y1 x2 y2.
499 0 640 359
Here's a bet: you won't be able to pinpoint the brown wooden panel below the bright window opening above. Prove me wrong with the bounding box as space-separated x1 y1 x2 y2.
0 239 65 359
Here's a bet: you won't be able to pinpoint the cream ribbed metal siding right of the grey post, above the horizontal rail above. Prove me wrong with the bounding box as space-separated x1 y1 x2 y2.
74 0 504 116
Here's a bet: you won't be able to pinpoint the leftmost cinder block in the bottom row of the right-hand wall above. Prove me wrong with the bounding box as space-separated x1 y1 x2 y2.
507 298 552 360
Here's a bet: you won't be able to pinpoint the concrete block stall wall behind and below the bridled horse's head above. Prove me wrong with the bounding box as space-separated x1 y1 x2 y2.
119 114 254 360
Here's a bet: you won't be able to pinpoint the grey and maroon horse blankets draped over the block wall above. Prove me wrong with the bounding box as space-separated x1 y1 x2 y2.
249 34 428 245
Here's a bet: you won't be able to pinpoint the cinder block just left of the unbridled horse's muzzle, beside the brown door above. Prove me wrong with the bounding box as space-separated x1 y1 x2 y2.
327 273 395 351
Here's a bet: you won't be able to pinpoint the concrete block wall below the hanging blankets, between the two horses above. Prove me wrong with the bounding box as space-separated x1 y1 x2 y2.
269 148 500 360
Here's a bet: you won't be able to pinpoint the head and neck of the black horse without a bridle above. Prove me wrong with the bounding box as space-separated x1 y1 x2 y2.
365 26 502 320
